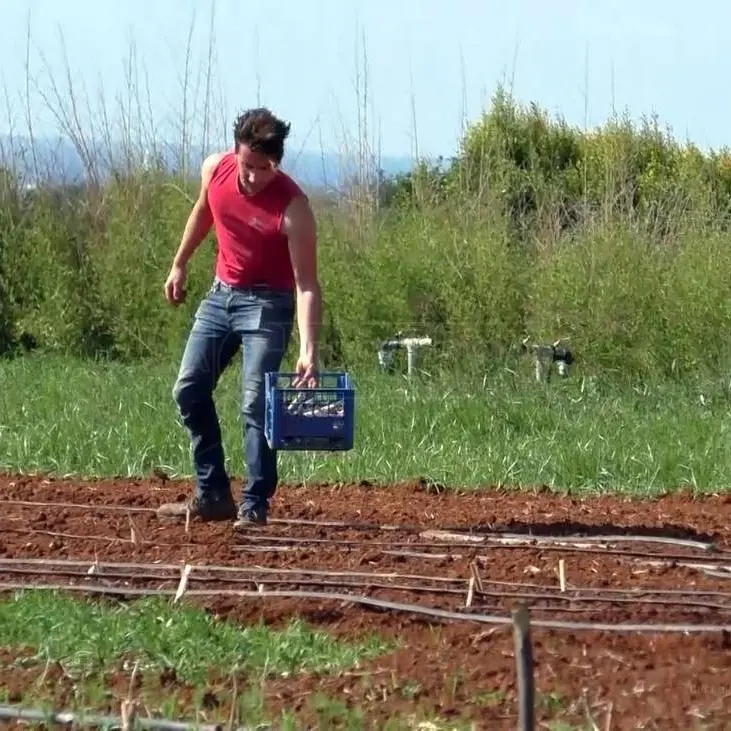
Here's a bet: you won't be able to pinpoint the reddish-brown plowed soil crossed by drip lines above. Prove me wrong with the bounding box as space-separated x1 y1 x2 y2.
0 475 731 731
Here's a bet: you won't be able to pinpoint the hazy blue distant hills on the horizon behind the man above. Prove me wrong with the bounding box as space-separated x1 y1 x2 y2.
0 136 420 189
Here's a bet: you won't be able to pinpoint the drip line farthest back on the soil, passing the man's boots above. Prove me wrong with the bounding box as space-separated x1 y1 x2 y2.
0 499 720 559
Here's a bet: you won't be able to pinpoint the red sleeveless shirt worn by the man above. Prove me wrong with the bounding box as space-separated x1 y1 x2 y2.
208 152 303 289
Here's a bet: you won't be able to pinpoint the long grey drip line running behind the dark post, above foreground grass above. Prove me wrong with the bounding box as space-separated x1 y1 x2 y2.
0 583 731 634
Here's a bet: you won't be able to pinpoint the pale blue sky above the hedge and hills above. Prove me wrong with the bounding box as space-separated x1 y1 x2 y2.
0 0 731 161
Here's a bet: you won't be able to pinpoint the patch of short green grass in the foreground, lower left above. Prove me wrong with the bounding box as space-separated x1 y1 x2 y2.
0 591 387 684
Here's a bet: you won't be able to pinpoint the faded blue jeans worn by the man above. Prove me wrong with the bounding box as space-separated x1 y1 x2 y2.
173 280 295 510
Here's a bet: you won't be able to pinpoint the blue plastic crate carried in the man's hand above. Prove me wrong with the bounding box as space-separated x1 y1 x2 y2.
264 371 355 452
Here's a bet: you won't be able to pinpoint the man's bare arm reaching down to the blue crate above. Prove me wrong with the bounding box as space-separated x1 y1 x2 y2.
284 196 322 367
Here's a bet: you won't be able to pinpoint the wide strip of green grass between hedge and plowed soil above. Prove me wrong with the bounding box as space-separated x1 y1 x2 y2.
0 356 731 495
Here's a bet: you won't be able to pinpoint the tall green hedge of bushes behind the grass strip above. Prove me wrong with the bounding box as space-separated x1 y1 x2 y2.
0 93 731 378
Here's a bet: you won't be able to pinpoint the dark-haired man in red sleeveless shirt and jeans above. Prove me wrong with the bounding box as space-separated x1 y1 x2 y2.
158 109 321 527
